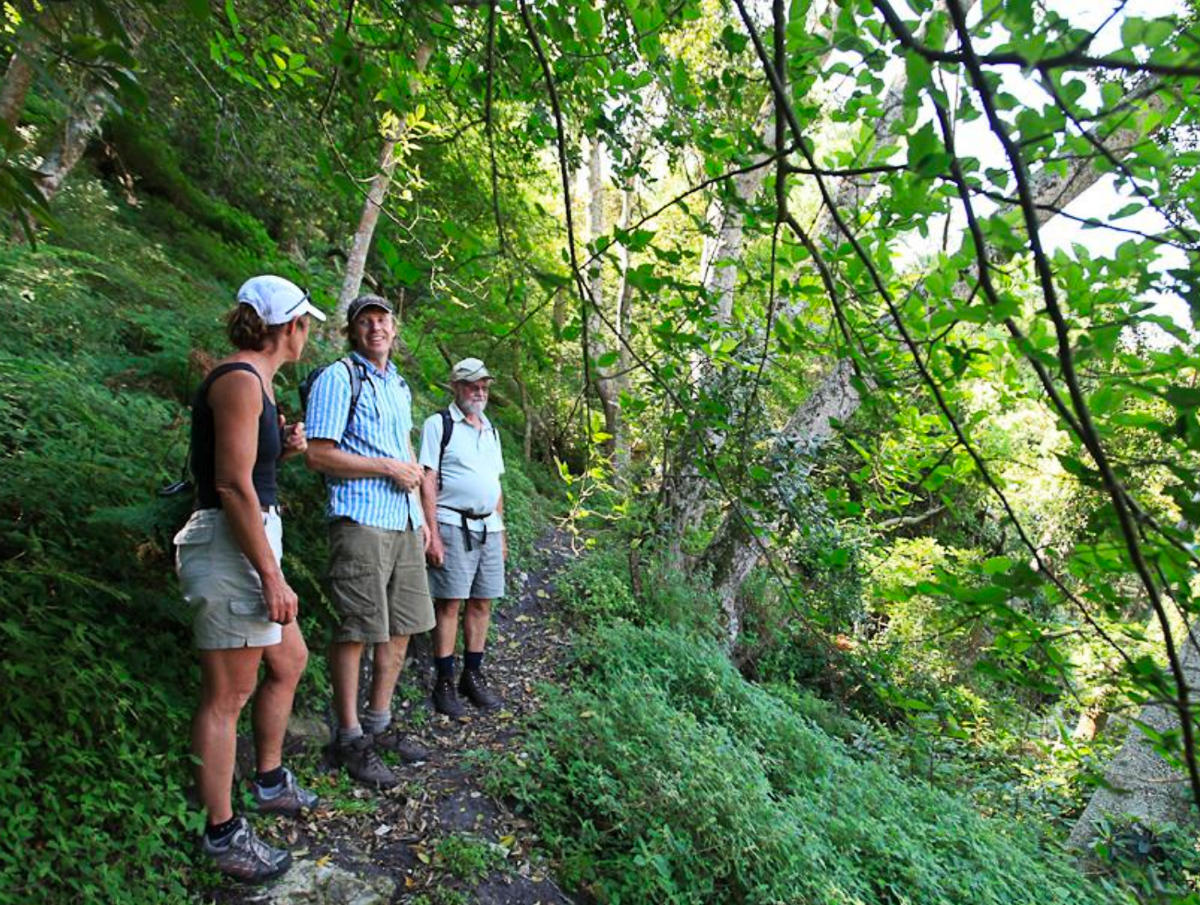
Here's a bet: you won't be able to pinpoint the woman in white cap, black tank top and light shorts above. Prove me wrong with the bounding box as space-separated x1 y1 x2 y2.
175 276 325 882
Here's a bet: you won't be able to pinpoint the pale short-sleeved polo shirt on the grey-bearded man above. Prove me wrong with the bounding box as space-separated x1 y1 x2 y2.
416 402 504 533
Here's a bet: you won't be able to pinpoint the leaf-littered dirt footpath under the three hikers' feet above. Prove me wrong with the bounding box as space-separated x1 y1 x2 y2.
210 533 574 905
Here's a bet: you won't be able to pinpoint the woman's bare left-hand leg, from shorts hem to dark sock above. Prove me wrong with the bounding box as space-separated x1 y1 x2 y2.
192 647 264 826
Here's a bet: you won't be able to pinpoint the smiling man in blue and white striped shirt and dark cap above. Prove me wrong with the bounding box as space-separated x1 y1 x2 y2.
305 295 434 789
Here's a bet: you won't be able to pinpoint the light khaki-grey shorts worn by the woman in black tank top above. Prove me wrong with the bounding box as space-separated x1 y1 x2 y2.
175 509 283 651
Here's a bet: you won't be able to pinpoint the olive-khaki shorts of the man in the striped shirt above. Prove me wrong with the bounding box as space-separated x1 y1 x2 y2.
329 519 436 645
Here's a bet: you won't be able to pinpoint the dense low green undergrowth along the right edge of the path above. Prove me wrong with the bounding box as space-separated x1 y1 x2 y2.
494 623 1122 905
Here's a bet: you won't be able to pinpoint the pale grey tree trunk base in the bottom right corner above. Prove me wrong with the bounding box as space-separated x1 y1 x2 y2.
1069 624 1200 849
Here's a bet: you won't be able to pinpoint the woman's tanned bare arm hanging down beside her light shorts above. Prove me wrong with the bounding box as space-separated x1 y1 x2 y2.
209 371 299 625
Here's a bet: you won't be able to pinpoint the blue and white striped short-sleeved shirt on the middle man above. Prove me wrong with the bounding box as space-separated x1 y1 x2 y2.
305 352 425 531
